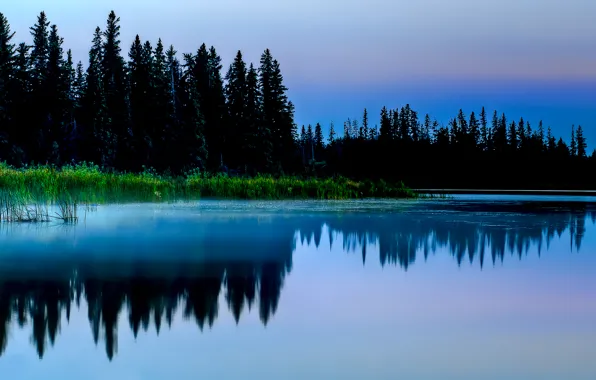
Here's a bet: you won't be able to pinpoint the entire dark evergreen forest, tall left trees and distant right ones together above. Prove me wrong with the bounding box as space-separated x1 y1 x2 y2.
0 11 596 189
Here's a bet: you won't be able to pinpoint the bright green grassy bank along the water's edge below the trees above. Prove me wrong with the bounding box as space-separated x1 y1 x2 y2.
0 164 420 203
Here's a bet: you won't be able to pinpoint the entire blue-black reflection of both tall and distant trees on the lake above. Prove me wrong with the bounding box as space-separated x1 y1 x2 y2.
0 202 596 360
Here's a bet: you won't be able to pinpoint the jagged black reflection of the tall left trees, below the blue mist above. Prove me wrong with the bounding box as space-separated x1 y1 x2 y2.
0 262 288 359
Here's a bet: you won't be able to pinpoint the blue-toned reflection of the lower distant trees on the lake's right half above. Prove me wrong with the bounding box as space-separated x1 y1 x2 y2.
318 202 596 270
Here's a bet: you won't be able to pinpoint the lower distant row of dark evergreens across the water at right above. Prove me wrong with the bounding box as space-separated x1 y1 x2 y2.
312 105 596 188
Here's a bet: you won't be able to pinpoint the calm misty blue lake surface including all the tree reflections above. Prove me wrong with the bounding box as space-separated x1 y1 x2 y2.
0 196 596 380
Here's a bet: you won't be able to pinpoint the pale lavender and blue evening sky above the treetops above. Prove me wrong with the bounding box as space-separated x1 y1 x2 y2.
2 0 596 147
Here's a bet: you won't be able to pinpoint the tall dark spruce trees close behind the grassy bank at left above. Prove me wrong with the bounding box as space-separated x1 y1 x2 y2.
0 12 295 172
